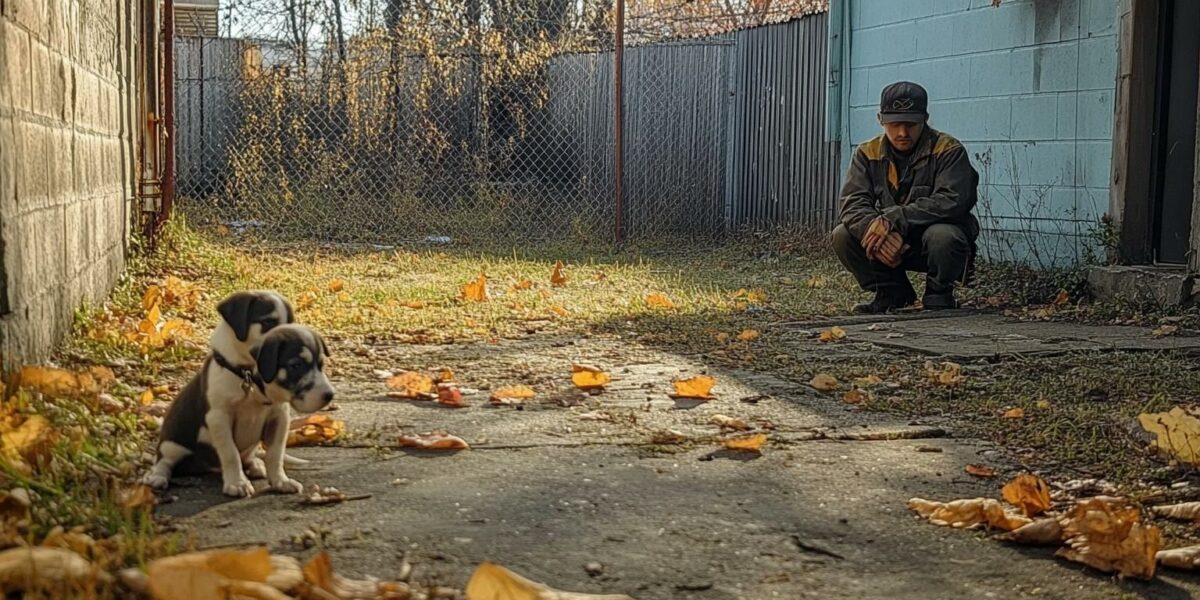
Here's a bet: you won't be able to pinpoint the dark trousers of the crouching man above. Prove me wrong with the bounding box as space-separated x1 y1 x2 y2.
833 223 971 296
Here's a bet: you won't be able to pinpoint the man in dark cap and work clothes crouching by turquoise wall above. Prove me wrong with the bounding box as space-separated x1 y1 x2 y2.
833 82 979 314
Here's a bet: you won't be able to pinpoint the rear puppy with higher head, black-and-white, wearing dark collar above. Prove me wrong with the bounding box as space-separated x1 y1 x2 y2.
144 290 323 496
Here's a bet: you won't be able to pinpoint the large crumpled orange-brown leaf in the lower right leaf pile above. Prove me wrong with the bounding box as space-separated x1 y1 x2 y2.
1056 498 1163 580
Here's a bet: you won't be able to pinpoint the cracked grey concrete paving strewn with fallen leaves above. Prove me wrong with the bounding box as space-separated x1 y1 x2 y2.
160 314 1200 600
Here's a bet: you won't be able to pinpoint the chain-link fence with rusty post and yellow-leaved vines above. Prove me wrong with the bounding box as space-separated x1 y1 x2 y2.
175 0 820 244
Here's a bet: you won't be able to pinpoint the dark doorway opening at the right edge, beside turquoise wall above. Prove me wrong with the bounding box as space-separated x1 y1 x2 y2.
1152 0 1200 264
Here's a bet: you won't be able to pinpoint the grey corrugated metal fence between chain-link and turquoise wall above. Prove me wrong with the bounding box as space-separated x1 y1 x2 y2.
545 13 839 236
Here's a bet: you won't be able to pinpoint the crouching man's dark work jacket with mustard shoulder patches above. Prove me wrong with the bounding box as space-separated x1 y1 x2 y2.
841 126 979 242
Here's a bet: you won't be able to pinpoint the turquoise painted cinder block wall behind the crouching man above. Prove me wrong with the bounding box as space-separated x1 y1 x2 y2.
830 0 1118 265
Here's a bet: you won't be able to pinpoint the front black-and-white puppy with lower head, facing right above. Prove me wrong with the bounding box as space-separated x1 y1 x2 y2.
146 324 334 497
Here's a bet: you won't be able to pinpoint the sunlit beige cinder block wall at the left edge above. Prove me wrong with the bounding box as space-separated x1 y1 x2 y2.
0 0 139 367
